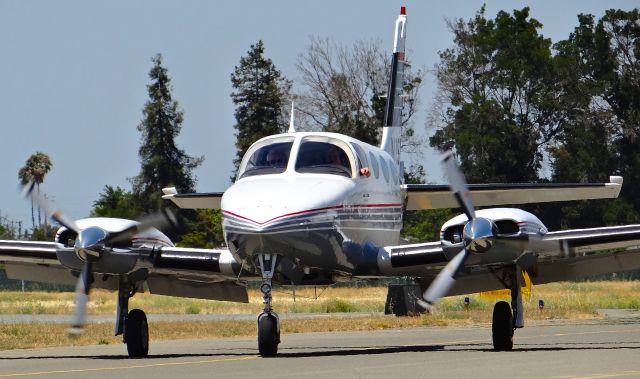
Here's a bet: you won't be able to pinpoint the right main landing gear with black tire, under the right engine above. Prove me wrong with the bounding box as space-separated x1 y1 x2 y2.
491 266 524 351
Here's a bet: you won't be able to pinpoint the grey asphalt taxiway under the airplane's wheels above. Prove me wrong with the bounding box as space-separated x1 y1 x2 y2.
0 315 640 379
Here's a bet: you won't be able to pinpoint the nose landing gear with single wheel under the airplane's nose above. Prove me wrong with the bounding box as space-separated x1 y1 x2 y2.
257 254 280 358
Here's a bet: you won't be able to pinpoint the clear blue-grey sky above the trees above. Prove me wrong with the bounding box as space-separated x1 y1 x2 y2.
0 0 638 227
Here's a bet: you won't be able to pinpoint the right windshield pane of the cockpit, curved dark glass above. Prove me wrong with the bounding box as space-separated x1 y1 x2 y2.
296 137 352 178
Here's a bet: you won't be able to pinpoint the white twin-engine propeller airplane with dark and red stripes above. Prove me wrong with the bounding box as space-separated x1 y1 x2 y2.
0 7 640 357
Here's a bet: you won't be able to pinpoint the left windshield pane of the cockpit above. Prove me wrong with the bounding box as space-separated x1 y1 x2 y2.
238 138 293 178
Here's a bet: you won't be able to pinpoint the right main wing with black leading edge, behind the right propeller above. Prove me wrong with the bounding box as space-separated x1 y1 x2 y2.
381 225 640 296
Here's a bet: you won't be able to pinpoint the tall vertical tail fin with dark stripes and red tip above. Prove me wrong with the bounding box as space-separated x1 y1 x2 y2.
381 7 407 164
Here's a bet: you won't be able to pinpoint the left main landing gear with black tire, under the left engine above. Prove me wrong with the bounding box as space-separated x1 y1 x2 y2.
115 281 149 358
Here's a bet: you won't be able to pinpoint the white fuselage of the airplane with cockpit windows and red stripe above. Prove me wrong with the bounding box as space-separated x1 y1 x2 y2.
222 133 403 273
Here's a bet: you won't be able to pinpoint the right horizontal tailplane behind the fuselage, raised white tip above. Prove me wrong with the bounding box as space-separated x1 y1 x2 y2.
403 176 622 211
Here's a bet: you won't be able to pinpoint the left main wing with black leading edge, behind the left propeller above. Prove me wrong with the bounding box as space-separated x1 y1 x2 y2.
0 241 249 303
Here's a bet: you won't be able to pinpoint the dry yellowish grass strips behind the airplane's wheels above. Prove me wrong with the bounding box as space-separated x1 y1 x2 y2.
0 281 640 349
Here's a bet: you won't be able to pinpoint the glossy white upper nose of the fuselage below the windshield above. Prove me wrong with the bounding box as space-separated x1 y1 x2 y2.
222 175 354 231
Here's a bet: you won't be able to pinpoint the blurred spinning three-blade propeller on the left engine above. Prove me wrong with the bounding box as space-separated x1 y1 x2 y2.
22 182 178 335
